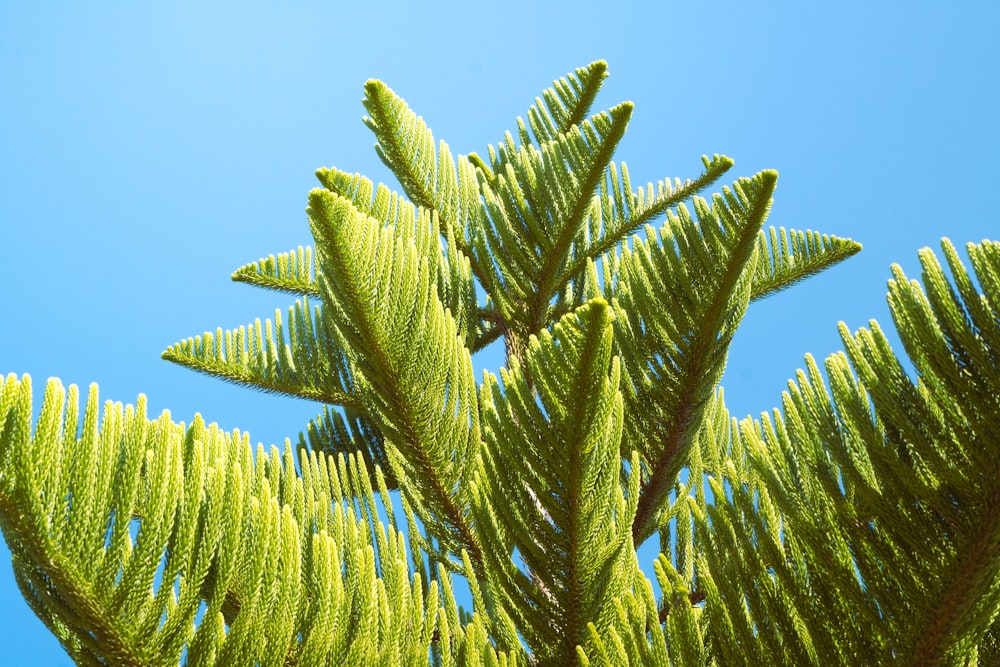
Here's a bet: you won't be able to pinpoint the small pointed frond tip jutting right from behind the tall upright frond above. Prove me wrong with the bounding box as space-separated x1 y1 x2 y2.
750 227 861 300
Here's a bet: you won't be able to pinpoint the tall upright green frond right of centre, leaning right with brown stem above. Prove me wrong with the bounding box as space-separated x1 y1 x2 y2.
606 171 777 544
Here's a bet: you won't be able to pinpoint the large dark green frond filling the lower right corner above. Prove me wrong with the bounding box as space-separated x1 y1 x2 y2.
700 240 1000 665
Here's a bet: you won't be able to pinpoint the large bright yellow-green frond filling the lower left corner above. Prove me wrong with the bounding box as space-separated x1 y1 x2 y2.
0 375 523 667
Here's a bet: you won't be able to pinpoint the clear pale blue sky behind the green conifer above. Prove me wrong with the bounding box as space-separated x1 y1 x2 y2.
0 0 1000 666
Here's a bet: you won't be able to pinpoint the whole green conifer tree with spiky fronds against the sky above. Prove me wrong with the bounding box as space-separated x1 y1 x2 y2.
0 62 1000 667
